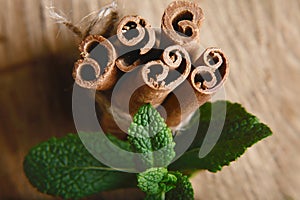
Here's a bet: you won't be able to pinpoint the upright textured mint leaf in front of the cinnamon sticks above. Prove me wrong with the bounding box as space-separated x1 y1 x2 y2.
128 104 175 171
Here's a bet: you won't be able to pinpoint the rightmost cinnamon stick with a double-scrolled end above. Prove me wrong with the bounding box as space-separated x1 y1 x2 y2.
161 48 229 129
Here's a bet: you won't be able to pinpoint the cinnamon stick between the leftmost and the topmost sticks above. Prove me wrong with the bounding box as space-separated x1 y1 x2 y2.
116 15 156 72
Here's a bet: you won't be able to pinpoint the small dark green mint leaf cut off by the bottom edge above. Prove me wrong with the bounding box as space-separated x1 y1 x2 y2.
165 172 194 200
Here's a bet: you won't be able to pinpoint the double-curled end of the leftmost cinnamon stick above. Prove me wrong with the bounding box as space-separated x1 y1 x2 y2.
73 35 118 90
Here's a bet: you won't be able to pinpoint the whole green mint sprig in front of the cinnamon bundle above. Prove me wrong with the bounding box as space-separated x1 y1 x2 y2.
24 101 271 200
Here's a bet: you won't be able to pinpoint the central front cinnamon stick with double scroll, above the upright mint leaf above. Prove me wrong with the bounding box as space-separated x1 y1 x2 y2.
113 45 191 116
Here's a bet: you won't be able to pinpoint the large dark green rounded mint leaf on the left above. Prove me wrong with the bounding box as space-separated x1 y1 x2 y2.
24 134 136 199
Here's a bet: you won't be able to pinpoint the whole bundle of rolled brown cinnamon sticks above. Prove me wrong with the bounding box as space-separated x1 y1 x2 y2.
73 1 229 138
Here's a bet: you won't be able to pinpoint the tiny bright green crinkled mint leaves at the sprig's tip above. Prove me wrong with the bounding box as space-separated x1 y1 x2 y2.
137 168 177 195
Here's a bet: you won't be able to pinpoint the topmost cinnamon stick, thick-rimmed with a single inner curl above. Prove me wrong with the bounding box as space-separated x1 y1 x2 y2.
161 1 204 60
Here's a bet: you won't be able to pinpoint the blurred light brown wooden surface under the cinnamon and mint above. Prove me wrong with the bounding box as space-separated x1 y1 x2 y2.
0 0 300 200
